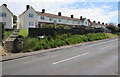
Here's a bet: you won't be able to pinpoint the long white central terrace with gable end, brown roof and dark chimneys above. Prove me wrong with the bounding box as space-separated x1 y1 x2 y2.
17 5 90 29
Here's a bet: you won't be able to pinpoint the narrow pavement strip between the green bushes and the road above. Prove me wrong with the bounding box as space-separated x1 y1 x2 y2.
0 37 116 62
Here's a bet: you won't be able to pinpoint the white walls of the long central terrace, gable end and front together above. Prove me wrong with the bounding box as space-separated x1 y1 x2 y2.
18 7 89 29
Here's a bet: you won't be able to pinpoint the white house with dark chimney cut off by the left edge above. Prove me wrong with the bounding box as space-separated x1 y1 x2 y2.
0 4 13 29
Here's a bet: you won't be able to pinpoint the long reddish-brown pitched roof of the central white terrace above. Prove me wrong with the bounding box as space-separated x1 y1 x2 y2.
36 11 85 21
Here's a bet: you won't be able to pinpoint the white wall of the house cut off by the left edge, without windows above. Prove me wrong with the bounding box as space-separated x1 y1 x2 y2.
0 5 13 29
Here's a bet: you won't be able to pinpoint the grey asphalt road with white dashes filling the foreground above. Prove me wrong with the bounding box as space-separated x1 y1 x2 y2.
2 39 118 75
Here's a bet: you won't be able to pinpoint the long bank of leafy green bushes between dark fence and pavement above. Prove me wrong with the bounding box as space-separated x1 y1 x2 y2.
22 33 117 52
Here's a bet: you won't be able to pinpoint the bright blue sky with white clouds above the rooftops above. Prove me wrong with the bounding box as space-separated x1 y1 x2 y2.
0 0 119 24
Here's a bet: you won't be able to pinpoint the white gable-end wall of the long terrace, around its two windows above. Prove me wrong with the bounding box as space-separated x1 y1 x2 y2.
18 7 38 29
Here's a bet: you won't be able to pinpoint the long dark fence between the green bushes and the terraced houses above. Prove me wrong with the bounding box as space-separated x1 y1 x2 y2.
29 28 110 37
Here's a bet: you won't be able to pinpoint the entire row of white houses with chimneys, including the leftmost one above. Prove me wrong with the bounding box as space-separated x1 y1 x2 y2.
0 4 108 29
